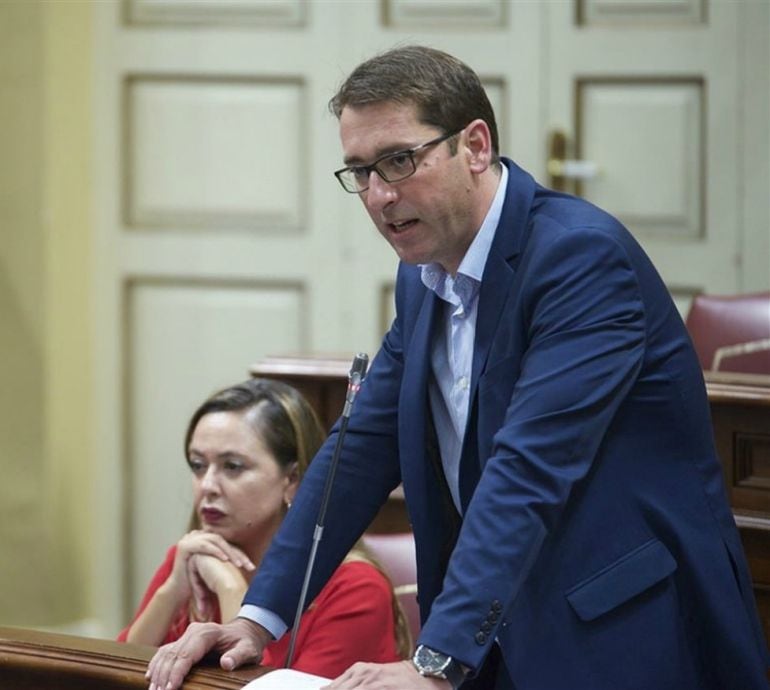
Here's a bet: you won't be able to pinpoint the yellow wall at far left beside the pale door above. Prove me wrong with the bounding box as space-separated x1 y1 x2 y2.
0 2 93 627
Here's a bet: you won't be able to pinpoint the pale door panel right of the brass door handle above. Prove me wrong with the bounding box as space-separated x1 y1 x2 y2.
576 77 706 239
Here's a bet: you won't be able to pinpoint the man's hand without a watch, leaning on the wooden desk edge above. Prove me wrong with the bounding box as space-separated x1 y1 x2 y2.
144 618 272 690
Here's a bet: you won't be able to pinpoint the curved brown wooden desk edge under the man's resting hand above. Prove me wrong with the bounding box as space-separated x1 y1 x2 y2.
0 627 268 690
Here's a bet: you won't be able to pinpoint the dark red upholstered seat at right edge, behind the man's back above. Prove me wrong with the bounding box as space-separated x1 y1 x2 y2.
686 292 770 374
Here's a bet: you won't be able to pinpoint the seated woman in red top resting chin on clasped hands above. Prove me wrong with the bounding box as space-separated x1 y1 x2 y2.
118 379 410 678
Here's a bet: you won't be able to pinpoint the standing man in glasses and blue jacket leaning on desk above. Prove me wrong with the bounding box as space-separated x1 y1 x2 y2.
148 47 768 690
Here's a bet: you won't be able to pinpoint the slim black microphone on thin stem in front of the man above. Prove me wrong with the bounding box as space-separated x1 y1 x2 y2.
285 352 369 668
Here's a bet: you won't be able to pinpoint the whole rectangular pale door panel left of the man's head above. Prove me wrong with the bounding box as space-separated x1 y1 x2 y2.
124 75 307 230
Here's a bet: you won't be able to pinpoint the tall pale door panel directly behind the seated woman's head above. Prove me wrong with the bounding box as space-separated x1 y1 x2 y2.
125 279 305 610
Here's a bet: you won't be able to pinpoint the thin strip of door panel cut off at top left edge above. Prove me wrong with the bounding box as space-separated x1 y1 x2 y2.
125 0 306 26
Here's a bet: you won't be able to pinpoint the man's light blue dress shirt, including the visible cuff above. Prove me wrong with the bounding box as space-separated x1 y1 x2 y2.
238 165 508 640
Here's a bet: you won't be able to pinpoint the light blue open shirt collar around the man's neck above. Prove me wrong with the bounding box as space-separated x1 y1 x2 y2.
420 165 508 307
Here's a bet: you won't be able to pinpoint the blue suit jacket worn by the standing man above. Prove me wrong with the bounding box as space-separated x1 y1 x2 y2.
246 161 768 690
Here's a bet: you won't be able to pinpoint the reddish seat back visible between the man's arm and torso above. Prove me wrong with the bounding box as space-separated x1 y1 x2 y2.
364 532 420 642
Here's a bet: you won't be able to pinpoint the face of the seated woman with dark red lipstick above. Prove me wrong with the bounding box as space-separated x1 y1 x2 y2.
188 409 296 552
